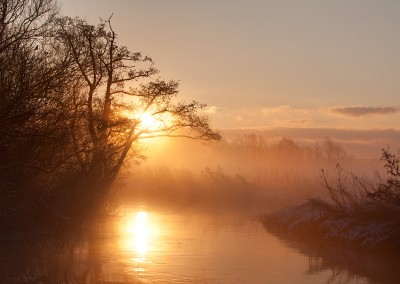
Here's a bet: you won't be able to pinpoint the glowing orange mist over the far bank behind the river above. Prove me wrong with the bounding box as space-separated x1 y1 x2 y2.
118 132 381 216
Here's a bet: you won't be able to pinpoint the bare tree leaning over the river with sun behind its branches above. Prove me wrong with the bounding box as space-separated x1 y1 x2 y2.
56 17 220 196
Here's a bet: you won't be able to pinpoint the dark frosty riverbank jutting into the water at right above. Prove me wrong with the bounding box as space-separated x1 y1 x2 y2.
260 199 400 250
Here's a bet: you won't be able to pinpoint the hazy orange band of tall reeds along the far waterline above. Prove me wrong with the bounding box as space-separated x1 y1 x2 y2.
122 167 320 213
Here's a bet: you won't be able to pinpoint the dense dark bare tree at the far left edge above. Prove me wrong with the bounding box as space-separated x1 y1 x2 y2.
0 0 82 224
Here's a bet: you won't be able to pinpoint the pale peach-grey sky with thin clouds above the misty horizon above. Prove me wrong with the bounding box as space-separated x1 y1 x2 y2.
59 0 400 155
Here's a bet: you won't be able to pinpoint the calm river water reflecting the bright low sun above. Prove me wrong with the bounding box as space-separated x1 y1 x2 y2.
0 206 400 283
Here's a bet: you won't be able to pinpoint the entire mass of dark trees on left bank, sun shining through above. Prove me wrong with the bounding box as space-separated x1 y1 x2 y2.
0 0 220 222
